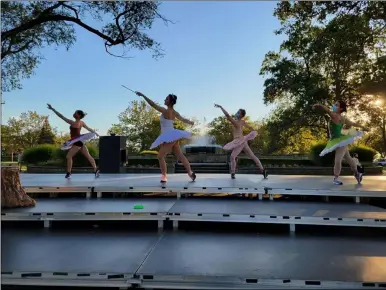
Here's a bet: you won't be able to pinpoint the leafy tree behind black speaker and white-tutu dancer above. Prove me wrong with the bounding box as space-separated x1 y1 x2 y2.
108 100 197 152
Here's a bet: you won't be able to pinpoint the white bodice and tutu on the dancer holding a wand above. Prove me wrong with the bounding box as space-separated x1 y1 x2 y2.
150 115 192 149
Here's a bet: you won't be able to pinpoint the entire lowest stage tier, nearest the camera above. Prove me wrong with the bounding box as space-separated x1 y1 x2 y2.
1 229 386 288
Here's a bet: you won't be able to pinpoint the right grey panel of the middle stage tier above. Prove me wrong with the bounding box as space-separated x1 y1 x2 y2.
169 199 386 220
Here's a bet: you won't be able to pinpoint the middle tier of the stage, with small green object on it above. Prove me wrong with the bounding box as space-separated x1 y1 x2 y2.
2 197 386 227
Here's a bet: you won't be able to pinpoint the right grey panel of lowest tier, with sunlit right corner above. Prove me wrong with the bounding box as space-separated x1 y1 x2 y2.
137 232 386 283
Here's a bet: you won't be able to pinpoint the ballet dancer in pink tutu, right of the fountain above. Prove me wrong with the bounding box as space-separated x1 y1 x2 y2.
214 104 268 179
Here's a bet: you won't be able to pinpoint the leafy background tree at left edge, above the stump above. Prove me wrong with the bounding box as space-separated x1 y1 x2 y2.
1 111 47 153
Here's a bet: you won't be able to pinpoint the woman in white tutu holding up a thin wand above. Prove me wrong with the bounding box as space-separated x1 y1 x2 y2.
136 92 196 183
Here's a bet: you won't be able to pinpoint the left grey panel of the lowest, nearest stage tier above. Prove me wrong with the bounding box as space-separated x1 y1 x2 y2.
1 229 159 274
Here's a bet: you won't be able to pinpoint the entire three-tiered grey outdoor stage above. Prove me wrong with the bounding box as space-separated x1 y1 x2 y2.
2 174 386 289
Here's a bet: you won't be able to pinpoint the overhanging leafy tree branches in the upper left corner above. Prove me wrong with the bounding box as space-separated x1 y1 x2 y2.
1 1 169 91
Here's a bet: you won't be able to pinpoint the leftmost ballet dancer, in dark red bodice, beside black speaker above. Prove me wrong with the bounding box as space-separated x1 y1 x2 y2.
47 104 99 178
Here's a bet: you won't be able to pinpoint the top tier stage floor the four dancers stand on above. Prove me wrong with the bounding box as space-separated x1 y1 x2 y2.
20 174 386 196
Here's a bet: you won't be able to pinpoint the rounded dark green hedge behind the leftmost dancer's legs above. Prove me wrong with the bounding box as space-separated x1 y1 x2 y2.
22 144 99 167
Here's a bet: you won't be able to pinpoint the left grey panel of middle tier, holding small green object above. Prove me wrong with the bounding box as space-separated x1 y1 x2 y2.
2 198 176 213
